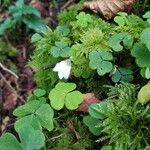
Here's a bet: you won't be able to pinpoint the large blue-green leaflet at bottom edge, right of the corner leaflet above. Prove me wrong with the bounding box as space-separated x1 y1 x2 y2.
19 125 45 150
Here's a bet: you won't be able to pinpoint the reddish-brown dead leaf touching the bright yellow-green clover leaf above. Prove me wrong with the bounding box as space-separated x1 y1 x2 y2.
77 93 100 112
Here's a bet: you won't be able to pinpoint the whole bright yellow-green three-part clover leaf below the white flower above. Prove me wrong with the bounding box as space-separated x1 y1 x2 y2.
49 82 83 110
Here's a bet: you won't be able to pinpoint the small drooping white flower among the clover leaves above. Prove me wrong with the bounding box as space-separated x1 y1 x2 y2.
53 59 71 79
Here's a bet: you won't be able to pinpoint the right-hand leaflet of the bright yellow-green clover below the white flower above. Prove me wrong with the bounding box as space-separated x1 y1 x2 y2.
65 91 83 110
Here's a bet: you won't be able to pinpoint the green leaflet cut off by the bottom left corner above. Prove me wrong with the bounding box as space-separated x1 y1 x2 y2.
0 133 23 150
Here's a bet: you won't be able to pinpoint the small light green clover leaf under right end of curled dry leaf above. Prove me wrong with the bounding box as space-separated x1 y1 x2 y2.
114 12 128 26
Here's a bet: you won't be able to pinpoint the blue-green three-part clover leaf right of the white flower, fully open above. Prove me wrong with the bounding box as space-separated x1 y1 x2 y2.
89 50 113 76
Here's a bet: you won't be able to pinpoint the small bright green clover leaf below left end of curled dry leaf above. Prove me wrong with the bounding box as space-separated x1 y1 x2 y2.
76 12 93 28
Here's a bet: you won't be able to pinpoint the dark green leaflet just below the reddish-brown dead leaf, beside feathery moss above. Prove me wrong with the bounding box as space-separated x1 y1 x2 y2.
83 116 102 136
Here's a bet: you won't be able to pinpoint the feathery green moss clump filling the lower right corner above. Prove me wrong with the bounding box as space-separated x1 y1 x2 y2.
84 84 150 150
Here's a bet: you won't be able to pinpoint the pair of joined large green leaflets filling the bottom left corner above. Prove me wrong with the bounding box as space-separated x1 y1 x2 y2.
0 126 45 150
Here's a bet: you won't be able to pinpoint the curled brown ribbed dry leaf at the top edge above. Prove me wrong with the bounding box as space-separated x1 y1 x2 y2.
82 0 135 20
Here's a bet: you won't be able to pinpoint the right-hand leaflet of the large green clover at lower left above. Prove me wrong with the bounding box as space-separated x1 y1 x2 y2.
36 104 54 131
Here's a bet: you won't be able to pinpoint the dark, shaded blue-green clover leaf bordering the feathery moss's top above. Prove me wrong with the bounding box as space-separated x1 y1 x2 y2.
111 67 133 83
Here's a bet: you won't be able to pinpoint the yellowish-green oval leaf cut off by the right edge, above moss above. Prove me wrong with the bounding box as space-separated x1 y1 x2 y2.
138 83 150 105
